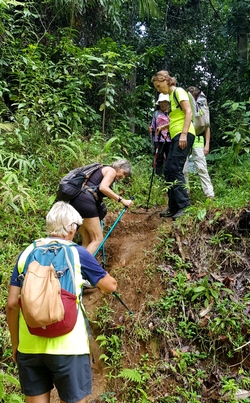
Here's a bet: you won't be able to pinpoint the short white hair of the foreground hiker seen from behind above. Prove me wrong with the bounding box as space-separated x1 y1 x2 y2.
46 201 83 236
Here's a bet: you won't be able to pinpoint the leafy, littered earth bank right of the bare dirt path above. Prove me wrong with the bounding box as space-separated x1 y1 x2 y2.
94 213 250 403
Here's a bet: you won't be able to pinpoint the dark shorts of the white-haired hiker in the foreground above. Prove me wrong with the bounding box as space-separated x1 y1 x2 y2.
18 352 92 403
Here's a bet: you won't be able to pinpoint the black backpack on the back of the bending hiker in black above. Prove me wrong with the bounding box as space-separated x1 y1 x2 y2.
56 162 103 202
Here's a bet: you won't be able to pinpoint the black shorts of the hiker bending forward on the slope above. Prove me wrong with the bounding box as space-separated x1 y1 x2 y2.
70 192 99 218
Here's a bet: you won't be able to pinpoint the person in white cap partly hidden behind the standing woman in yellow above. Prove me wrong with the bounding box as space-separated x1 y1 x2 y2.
148 94 171 175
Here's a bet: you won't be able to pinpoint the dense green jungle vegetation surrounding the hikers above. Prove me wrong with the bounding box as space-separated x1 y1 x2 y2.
0 0 250 403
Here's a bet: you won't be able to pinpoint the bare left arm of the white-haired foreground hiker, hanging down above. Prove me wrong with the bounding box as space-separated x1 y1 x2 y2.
6 285 20 363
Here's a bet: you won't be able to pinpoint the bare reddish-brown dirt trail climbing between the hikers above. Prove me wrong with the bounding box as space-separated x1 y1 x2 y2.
51 209 162 403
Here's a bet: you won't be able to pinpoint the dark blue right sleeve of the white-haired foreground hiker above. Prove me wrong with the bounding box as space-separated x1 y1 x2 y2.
75 245 107 286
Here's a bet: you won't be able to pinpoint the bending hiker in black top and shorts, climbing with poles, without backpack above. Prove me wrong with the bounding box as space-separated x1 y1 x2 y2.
70 159 133 254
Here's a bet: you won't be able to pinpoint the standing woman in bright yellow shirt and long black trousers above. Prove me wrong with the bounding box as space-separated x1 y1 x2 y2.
151 70 195 220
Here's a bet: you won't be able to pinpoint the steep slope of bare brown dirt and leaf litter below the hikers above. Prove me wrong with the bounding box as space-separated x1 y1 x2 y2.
52 209 250 403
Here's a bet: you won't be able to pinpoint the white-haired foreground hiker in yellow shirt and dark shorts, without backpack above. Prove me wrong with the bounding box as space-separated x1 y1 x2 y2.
6 202 117 403
